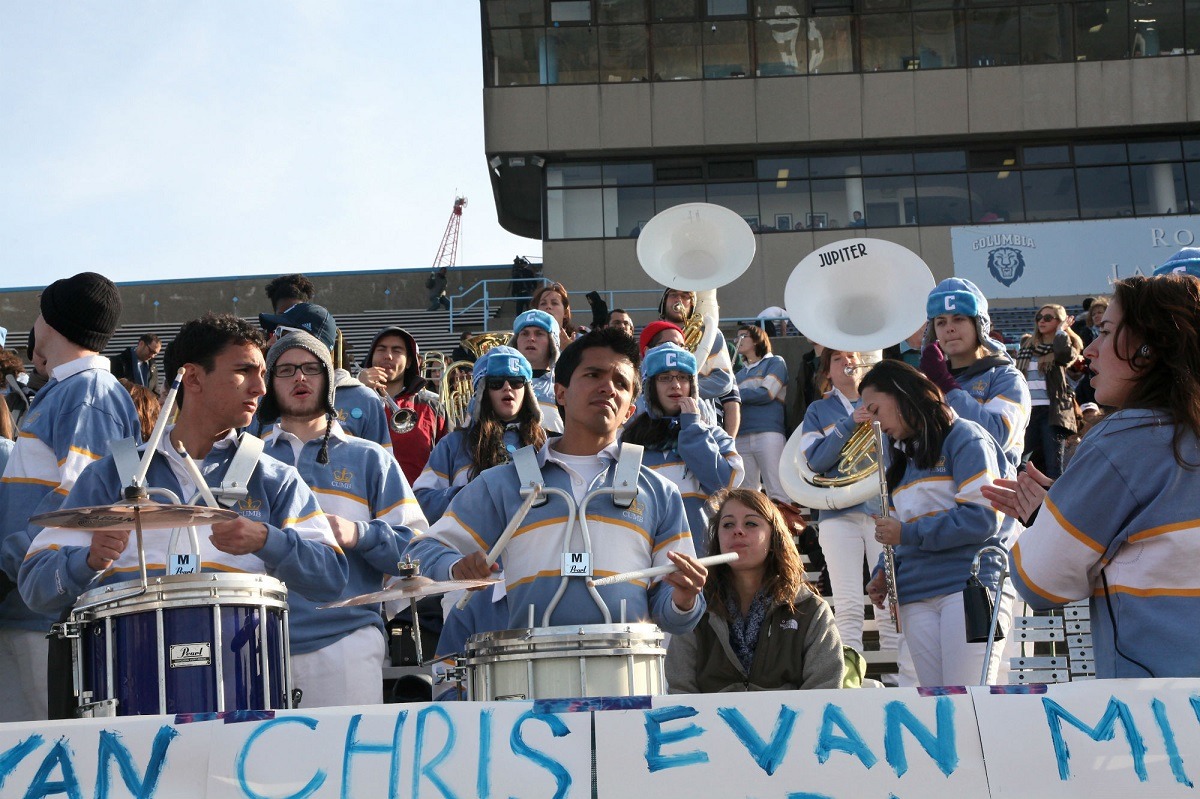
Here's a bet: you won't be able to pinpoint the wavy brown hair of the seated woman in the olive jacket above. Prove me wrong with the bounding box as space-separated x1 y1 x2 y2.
704 488 816 618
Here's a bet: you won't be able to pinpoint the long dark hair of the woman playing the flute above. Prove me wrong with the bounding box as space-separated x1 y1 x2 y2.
858 359 953 489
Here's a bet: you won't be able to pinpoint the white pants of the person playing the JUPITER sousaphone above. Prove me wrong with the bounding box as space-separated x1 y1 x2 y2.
817 511 900 651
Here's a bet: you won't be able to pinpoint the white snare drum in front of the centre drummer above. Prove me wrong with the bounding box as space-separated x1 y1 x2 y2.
463 624 666 701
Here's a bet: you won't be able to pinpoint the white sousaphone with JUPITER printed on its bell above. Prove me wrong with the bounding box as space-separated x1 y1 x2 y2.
779 239 934 510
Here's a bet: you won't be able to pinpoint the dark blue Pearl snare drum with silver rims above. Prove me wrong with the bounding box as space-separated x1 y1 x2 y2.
68 572 292 716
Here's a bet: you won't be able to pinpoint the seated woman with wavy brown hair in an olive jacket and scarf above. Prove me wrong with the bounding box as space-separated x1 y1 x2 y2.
666 488 845 693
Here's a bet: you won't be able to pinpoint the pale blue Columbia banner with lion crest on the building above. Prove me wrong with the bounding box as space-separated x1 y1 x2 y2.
950 215 1200 300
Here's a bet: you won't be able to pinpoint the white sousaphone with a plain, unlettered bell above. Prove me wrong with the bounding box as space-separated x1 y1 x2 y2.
637 203 757 374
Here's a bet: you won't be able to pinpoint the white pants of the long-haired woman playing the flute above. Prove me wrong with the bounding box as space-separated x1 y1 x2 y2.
900 591 1013 687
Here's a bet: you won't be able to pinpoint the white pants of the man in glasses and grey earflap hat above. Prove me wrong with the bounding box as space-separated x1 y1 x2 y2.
292 626 388 708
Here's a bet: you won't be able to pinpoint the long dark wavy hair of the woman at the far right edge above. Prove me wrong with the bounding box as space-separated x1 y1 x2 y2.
1112 275 1200 468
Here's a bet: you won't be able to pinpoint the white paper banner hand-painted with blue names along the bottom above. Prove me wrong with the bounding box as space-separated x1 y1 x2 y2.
0 679 1200 799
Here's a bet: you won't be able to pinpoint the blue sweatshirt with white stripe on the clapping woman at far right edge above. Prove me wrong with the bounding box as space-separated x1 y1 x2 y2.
1012 409 1200 678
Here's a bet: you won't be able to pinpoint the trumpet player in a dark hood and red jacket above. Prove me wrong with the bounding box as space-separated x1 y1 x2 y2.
359 325 448 485
